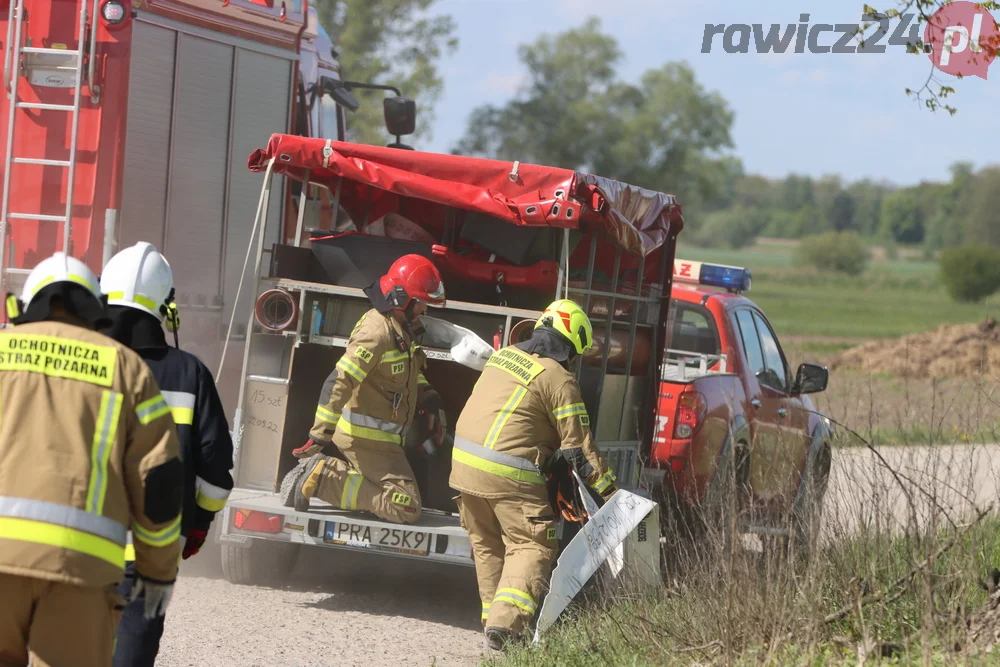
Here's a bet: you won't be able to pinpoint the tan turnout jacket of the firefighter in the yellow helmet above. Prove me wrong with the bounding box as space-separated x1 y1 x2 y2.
450 345 615 498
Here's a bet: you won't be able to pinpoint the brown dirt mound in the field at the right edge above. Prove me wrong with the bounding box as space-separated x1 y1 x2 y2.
830 317 1000 378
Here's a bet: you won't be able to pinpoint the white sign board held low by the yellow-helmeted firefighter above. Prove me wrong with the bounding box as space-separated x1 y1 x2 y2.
534 489 656 642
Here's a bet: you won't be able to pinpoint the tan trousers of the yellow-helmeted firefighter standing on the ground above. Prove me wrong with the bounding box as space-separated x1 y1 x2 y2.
456 493 559 635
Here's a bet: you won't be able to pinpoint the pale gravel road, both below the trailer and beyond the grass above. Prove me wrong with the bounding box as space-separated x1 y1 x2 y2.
157 446 1000 667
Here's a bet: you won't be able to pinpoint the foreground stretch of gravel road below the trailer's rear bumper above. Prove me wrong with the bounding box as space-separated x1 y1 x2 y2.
156 547 486 667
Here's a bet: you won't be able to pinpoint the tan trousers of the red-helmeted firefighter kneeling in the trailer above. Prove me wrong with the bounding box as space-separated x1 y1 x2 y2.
302 442 420 524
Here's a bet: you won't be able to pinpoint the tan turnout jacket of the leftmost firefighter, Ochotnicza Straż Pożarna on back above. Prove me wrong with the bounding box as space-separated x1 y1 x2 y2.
0 321 183 586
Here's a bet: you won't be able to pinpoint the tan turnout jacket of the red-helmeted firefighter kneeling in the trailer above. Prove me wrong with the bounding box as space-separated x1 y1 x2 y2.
309 308 430 448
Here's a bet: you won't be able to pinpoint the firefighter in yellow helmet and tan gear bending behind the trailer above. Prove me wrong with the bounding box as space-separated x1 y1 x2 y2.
450 299 617 649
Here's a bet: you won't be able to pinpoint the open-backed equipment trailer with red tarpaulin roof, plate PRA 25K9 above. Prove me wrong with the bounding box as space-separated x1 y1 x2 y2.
219 134 683 583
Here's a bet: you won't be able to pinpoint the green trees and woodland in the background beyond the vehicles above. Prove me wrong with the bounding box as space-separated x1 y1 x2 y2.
315 0 1000 298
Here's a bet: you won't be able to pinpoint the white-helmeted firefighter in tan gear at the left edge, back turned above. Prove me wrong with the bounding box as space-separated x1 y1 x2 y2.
0 253 184 667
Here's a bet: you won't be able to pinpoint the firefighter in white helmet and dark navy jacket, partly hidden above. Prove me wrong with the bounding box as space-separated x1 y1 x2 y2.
101 243 233 667
